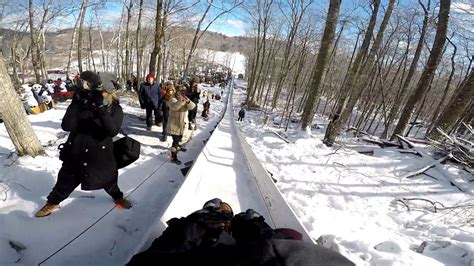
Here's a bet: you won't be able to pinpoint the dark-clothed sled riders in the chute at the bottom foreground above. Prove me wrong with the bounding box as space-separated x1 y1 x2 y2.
127 198 354 266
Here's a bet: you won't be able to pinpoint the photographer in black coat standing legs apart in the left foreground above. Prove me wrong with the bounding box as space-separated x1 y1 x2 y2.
35 71 131 217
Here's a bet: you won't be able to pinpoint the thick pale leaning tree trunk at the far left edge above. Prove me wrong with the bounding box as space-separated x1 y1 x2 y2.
0 55 44 157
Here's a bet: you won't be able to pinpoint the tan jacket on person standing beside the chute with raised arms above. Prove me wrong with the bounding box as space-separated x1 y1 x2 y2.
167 97 196 136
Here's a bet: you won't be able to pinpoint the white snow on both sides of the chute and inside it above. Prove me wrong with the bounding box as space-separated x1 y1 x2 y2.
0 78 474 266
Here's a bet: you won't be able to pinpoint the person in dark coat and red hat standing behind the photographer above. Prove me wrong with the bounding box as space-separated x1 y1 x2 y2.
139 74 163 130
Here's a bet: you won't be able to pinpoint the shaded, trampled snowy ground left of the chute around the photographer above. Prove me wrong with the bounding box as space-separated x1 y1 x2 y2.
0 84 223 265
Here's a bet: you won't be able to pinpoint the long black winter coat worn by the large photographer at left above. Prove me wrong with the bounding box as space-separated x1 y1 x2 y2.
61 94 123 190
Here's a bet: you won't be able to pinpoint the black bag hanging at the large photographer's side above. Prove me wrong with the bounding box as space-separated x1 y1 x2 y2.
114 136 140 169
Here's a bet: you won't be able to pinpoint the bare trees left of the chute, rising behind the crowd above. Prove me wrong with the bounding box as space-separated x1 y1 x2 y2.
0 0 242 156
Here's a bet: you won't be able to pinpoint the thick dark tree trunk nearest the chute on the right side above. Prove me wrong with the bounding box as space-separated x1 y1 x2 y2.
301 0 341 131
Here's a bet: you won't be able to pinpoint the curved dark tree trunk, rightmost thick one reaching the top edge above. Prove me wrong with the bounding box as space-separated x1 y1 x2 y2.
391 0 451 139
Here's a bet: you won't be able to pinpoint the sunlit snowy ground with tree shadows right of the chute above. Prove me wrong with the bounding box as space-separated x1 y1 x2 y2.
234 81 474 266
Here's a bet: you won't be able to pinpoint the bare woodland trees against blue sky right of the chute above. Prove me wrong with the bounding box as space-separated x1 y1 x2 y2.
246 0 474 146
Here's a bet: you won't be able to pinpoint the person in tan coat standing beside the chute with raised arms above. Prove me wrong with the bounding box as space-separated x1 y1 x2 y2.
167 87 196 165
